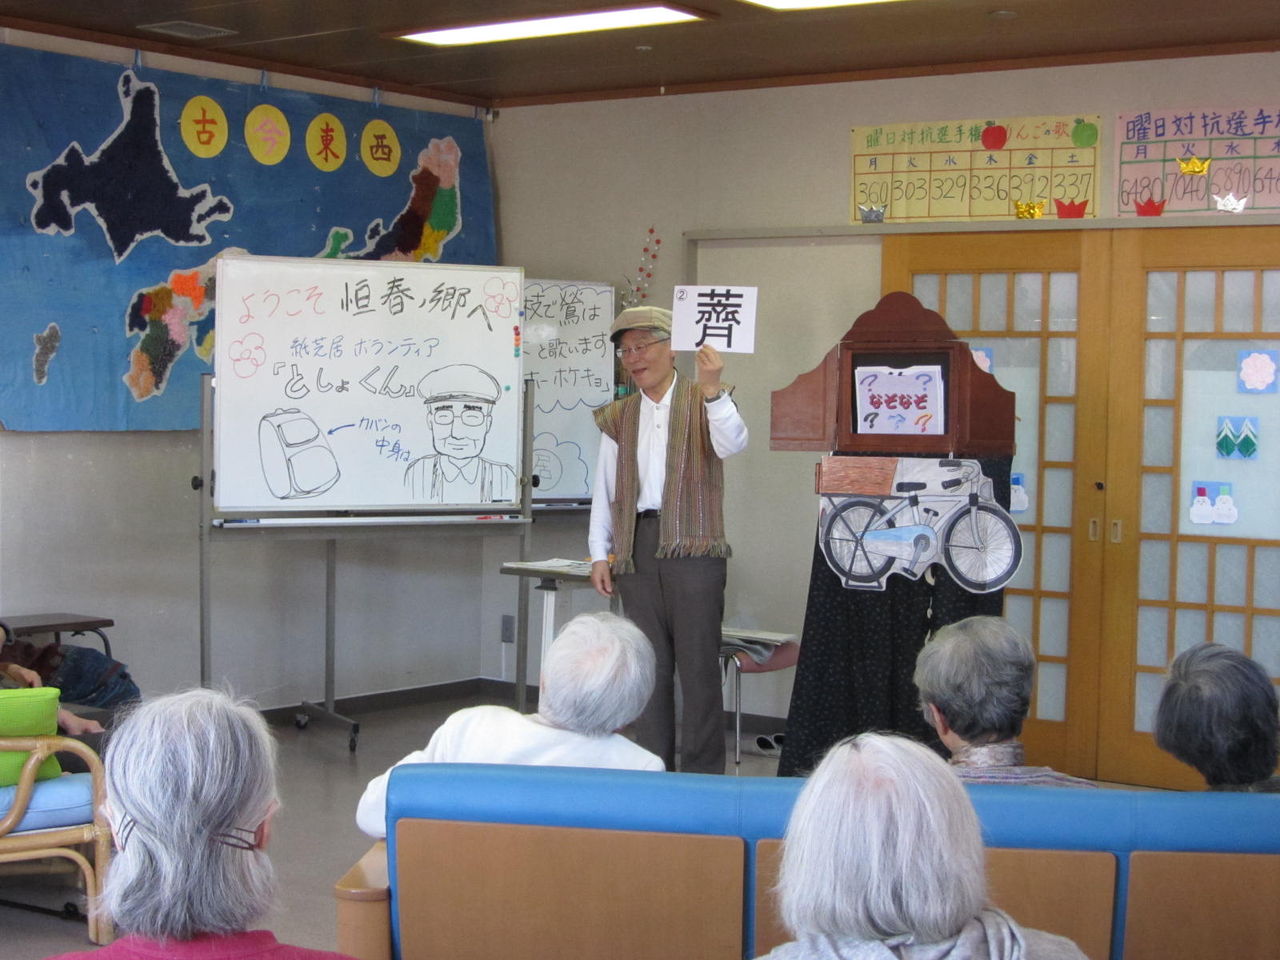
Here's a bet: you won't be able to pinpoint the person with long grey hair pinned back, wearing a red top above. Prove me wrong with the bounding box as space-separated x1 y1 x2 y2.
46 690 349 960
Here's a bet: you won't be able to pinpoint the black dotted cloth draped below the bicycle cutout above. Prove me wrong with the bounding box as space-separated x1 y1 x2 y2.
778 457 1011 777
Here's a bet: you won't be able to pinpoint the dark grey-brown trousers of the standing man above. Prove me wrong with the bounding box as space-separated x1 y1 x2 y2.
617 517 727 773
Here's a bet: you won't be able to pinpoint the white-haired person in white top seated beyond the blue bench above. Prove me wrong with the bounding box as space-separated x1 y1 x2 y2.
356 613 666 837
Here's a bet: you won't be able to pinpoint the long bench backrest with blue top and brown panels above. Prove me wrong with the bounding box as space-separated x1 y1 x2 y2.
388 764 1280 960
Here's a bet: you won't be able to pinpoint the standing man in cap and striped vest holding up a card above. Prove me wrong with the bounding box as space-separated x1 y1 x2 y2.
589 307 748 773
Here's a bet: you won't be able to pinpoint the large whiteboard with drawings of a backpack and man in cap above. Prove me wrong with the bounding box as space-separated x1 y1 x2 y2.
214 256 524 512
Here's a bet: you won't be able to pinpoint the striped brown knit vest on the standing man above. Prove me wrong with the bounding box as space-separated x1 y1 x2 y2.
595 378 731 573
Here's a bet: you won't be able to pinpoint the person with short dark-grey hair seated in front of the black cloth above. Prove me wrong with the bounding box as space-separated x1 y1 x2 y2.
915 617 1096 787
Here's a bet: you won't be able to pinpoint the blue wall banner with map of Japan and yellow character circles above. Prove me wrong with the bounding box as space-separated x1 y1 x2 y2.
0 46 497 430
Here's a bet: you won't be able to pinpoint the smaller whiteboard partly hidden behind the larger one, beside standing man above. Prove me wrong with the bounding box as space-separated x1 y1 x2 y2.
525 280 614 502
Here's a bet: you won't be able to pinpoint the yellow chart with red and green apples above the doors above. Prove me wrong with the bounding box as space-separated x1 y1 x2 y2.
850 114 1100 223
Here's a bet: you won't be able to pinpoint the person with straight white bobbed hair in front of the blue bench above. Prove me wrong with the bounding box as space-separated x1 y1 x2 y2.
767 733 1084 960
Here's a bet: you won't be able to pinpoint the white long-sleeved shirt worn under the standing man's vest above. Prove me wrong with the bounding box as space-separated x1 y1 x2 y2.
588 374 748 562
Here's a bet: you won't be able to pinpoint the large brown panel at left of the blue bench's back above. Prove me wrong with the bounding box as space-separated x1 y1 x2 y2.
397 819 744 960
